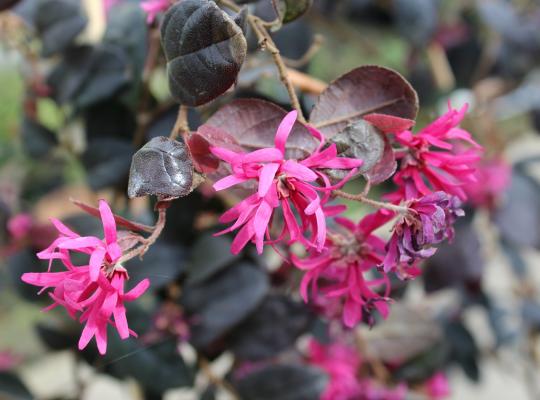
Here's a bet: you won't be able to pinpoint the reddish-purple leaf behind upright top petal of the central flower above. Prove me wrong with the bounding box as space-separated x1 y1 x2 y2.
206 99 317 159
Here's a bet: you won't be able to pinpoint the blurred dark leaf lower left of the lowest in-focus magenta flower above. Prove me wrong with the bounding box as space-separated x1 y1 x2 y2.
231 295 313 361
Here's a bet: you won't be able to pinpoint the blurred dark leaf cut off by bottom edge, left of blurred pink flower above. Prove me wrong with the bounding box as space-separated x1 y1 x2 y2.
235 364 328 400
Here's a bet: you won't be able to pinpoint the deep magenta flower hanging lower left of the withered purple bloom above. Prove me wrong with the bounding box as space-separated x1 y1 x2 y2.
293 211 393 328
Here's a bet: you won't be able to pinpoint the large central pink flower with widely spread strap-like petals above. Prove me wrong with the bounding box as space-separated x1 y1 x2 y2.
210 111 362 254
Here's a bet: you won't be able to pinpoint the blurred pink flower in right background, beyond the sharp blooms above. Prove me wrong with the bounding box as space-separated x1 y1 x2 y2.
464 158 512 209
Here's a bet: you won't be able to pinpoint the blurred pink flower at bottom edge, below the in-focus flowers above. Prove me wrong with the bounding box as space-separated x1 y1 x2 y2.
308 340 363 400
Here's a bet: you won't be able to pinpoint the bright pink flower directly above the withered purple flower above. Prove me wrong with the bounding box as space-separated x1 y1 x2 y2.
394 106 482 200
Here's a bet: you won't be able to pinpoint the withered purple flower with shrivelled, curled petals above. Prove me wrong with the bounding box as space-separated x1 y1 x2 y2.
383 192 464 272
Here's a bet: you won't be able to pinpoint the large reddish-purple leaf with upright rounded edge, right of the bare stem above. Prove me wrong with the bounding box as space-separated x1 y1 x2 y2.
310 65 418 138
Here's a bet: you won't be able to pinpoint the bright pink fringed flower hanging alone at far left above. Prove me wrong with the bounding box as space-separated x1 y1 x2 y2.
22 200 150 354
